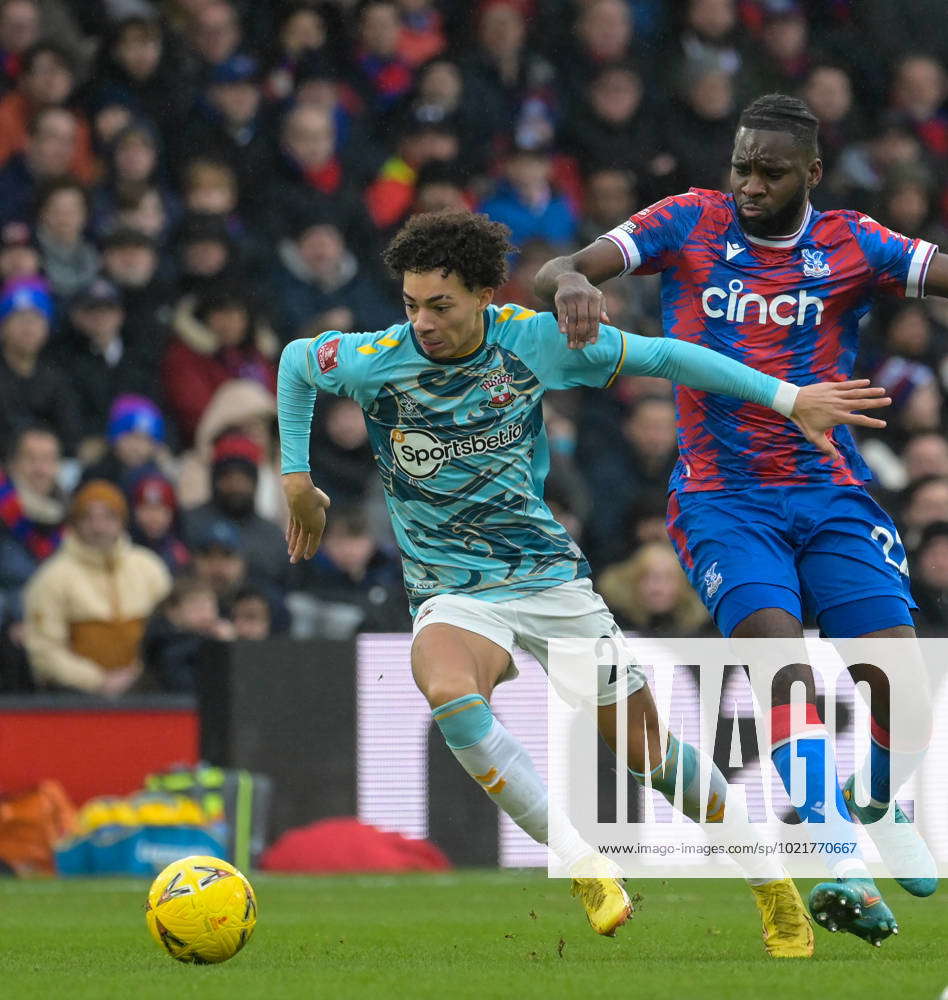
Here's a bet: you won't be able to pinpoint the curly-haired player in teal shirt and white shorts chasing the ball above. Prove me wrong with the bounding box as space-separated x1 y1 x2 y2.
278 213 888 956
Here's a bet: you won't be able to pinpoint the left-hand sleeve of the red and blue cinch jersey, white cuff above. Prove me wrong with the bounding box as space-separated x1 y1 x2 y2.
599 191 702 274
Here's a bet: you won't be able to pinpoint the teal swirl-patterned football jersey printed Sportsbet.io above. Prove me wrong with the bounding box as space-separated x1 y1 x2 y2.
281 305 628 610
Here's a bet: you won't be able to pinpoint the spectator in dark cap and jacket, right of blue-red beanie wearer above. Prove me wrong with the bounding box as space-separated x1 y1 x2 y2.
55 278 154 442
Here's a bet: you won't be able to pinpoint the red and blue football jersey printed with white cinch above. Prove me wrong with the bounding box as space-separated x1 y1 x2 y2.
600 188 937 492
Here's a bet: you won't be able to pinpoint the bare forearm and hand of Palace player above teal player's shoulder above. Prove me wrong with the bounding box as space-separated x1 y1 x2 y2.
533 240 625 348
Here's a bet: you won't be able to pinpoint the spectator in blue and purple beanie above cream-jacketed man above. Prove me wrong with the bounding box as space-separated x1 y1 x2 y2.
83 394 172 497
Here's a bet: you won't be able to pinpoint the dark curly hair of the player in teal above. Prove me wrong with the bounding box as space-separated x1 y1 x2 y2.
382 209 513 291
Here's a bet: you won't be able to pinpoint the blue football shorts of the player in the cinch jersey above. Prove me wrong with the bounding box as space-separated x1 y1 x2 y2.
667 485 916 638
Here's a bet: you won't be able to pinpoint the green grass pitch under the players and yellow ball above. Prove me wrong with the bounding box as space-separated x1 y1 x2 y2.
0 871 948 1000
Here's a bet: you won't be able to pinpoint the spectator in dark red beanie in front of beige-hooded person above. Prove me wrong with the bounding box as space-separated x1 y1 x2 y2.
184 434 289 592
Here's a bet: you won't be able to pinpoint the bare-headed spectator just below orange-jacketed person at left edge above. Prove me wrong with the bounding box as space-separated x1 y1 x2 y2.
0 107 79 223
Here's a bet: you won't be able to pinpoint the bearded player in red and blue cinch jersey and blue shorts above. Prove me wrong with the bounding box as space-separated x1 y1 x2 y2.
536 94 948 944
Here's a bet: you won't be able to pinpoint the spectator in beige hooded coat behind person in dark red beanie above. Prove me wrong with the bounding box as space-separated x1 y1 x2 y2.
177 379 286 527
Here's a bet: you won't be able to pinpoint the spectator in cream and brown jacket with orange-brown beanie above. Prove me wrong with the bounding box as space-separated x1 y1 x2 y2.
24 480 171 696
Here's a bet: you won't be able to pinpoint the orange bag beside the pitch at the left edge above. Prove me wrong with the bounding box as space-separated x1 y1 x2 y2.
0 781 76 875
